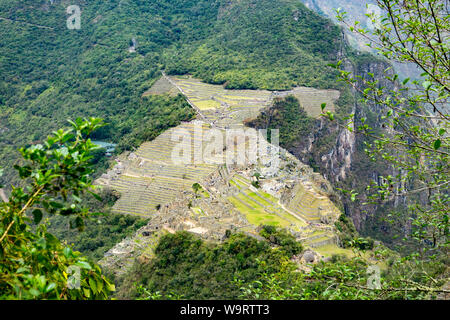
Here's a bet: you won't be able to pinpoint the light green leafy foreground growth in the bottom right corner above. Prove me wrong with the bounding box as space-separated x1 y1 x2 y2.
237 248 448 300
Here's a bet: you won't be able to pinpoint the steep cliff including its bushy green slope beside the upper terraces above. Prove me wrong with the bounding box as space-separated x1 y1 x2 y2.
247 36 407 248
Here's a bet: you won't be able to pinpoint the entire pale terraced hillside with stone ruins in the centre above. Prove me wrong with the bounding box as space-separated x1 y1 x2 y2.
98 73 340 258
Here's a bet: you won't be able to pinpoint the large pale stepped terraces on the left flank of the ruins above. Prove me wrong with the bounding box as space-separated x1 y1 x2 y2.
97 122 216 216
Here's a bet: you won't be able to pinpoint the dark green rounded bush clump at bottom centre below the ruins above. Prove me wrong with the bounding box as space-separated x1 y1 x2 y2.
118 227 302 299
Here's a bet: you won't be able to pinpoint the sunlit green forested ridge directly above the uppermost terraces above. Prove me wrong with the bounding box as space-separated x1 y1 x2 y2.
164 0 340 90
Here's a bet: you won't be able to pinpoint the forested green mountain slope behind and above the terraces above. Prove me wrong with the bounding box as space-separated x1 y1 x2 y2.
0 0 340 183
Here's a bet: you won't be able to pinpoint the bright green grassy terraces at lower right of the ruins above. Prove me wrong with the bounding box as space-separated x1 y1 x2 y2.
228 174 340 248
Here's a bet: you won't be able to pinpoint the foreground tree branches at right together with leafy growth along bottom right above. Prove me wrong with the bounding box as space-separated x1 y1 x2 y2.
241 0 450 299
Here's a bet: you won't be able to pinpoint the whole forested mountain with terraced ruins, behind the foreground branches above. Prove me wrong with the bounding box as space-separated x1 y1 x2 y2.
0 0 442 299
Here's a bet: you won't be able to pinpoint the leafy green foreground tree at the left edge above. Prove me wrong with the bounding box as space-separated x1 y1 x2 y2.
0 118 114 299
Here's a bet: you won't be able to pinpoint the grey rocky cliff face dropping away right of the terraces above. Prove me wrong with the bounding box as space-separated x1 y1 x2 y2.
264 44 402 233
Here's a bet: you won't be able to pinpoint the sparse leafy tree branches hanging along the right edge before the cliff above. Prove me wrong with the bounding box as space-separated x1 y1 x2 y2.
330 0 450 253
